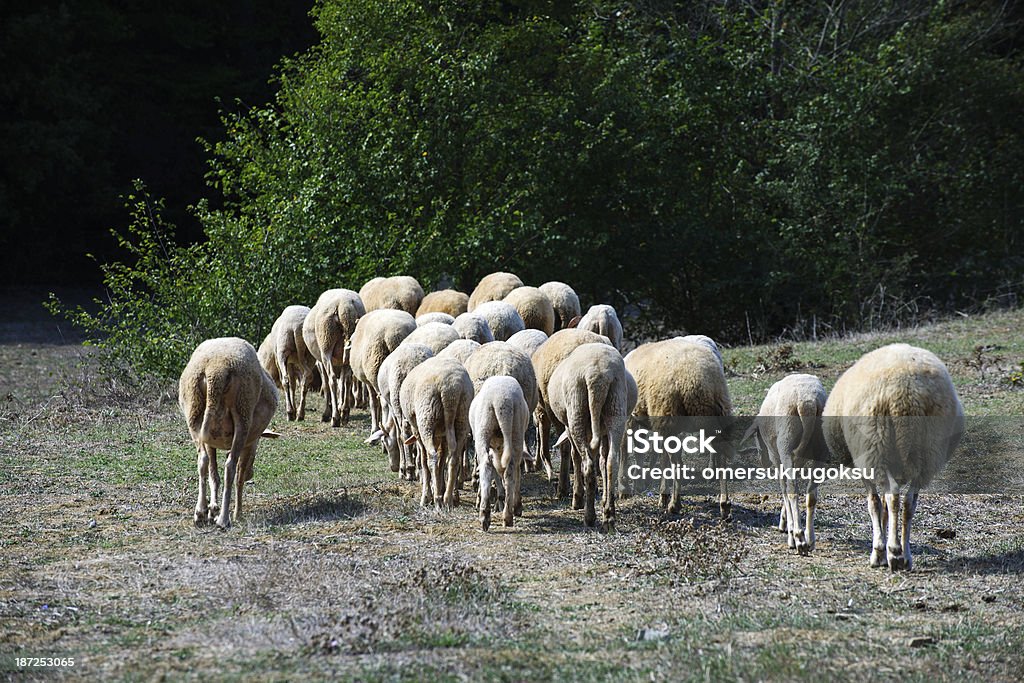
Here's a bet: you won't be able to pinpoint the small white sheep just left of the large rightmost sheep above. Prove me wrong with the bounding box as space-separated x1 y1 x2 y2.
745 370 827 555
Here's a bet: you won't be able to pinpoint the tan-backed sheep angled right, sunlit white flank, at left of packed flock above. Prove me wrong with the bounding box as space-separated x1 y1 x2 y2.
351 308 416 434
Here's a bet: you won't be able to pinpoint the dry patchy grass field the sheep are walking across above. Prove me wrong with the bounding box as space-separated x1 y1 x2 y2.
0 311 1024 681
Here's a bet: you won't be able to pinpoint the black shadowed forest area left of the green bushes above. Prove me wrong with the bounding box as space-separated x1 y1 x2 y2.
0 0 316 286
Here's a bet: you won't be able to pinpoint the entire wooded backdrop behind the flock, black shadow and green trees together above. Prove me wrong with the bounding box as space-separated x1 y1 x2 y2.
8 0 1024 377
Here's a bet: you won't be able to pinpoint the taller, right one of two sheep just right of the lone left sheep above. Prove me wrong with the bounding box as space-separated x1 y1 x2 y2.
309 289 366 427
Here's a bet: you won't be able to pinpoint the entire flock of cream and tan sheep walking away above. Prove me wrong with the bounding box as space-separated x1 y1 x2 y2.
178 272 963 569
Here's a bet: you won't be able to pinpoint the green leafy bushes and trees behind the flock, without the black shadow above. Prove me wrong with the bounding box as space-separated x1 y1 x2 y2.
59 0 1024 375
